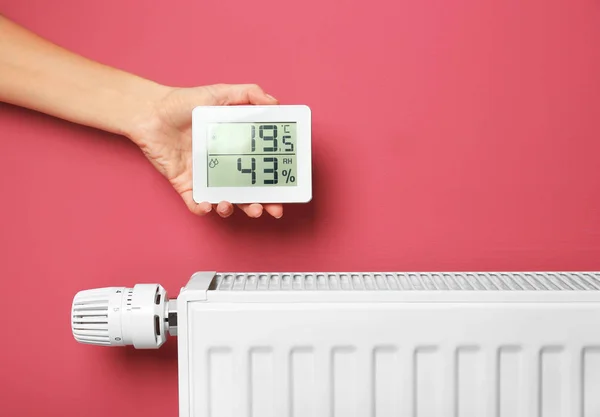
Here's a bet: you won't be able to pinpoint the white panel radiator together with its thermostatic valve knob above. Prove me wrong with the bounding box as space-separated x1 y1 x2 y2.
72 272 600 417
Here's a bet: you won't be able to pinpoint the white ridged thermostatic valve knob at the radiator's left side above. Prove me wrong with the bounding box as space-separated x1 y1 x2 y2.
71 284 169 349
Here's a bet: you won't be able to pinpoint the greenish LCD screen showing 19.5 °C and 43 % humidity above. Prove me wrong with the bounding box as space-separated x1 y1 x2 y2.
207 123 297 187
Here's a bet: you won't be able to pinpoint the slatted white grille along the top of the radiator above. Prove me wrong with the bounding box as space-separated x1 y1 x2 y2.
210 272 600 291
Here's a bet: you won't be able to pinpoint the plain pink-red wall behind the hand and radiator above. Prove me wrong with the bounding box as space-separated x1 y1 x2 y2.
0 0 600 417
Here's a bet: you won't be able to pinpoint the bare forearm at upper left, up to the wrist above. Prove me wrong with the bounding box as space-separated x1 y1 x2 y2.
0 16 166 136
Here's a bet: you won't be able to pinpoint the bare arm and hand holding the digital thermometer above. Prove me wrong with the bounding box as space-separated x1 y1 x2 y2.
0 15 283 218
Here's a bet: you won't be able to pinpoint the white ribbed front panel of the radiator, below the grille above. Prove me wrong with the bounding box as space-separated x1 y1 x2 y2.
180 302 600 417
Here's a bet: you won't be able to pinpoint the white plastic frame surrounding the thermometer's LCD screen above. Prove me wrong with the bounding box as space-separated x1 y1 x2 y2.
192 105 312 204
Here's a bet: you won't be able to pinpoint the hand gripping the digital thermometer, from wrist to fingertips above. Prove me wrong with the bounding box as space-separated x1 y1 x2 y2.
129 84 283 218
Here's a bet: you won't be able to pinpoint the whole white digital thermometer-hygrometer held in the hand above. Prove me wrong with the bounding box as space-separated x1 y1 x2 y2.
192 105 312 204
